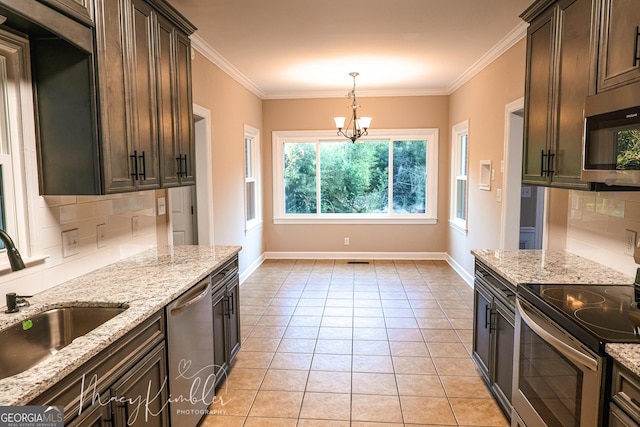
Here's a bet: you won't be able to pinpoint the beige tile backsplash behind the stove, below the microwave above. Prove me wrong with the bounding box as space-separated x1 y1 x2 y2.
567 190 640 276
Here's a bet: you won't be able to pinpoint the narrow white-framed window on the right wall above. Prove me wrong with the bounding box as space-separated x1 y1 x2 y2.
450 120 469 233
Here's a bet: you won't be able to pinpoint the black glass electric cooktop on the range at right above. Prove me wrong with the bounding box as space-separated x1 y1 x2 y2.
518 285 640 355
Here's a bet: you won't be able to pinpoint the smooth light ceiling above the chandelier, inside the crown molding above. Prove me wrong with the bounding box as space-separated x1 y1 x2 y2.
170 0 532 99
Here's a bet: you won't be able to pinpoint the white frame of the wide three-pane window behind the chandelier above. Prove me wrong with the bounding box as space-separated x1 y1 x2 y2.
272 128 439 224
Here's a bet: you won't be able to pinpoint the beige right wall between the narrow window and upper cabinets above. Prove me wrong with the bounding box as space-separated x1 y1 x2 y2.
444 39 526 281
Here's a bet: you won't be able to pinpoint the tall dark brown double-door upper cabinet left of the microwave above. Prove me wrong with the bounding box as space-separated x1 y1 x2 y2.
521 0 600 190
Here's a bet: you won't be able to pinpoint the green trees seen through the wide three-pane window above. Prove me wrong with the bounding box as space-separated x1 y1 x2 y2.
284 141 427 214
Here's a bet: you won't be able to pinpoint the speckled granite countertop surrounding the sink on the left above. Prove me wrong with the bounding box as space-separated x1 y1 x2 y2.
0 246 241 406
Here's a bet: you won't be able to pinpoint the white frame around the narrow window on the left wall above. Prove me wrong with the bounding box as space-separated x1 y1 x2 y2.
242 124 262 233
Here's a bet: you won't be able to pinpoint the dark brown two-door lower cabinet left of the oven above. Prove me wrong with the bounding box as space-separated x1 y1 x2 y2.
473 263 515 418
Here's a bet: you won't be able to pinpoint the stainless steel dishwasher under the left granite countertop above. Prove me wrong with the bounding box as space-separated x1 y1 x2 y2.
166 277 215 427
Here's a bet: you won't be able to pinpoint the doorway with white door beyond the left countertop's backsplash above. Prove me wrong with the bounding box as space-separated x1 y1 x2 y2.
167 104 214 246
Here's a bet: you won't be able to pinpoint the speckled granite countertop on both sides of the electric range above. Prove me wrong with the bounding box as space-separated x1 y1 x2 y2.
471 249 640 376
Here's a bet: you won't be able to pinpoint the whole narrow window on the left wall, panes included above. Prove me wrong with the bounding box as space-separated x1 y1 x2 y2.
244 125 262 230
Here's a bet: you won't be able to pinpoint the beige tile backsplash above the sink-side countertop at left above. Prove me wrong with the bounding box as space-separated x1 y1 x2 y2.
0 191 157 300
